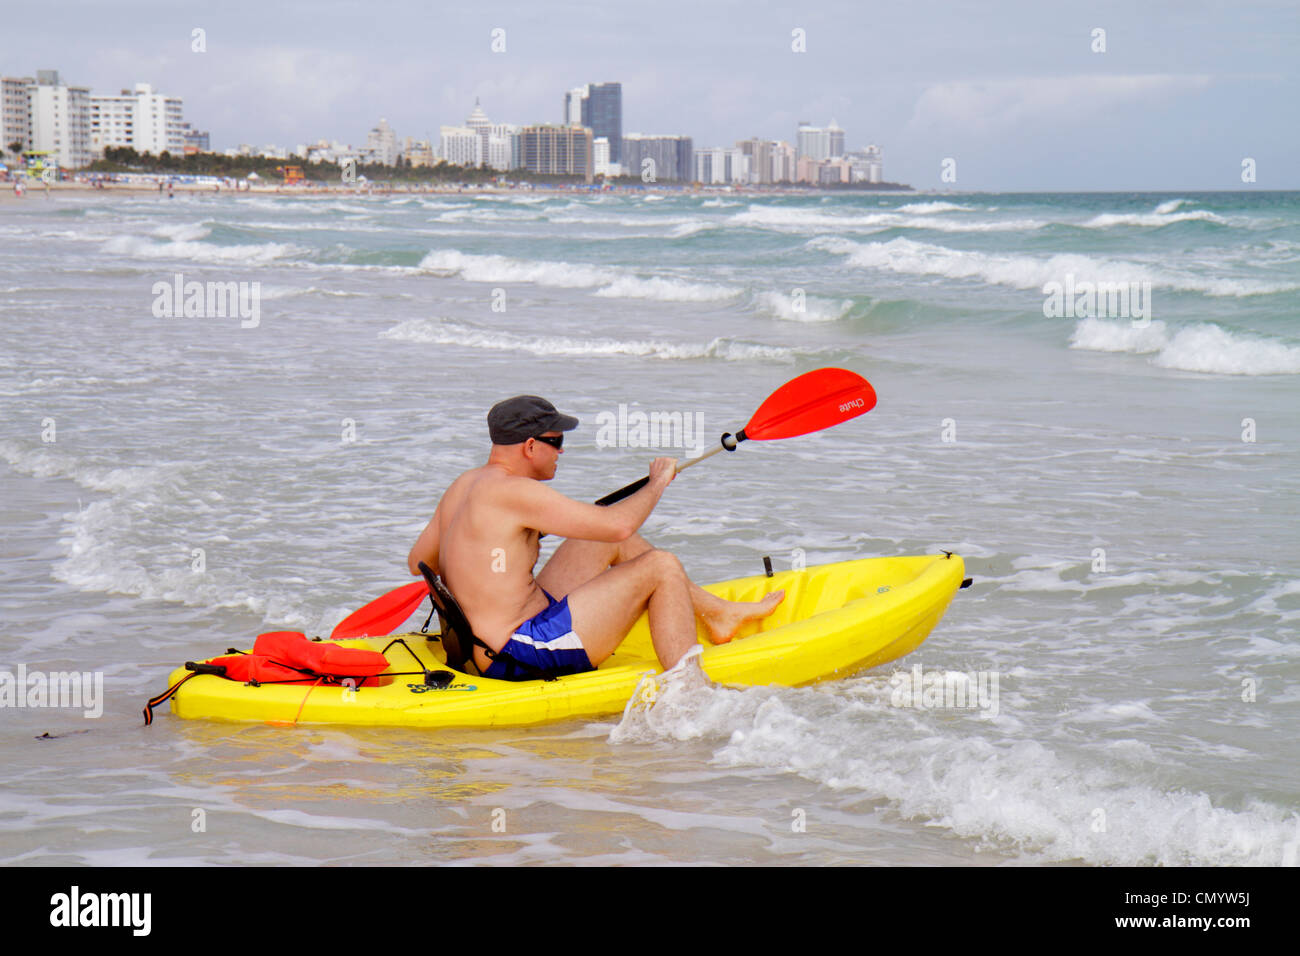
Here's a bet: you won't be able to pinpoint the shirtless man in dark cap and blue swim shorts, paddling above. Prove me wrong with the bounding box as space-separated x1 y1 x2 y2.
407 395 785 679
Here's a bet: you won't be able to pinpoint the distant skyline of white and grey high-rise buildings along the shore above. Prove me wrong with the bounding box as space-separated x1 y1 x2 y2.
0 69 883 186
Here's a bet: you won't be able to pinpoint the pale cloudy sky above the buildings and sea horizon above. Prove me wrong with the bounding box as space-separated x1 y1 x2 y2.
0 0 1300 191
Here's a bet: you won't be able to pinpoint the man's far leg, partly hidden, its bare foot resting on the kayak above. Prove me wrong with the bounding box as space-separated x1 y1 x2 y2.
537 535 785 644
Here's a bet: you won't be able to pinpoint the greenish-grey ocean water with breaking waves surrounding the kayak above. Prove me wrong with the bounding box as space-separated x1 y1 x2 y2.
0 193 1300 865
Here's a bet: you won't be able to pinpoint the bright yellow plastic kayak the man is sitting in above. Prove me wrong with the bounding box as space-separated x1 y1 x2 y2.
169 554 965 727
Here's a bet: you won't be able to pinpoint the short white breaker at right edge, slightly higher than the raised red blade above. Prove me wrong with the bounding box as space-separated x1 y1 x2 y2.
1070 319 1300 375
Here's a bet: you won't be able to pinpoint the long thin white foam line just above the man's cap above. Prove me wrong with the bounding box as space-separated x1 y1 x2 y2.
380 319 813 362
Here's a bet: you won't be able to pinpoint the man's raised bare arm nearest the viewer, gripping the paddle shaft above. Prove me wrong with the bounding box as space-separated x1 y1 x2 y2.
501 458 677 542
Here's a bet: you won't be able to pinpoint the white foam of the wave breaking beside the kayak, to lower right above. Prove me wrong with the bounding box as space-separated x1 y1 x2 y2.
610 674 1300 866
